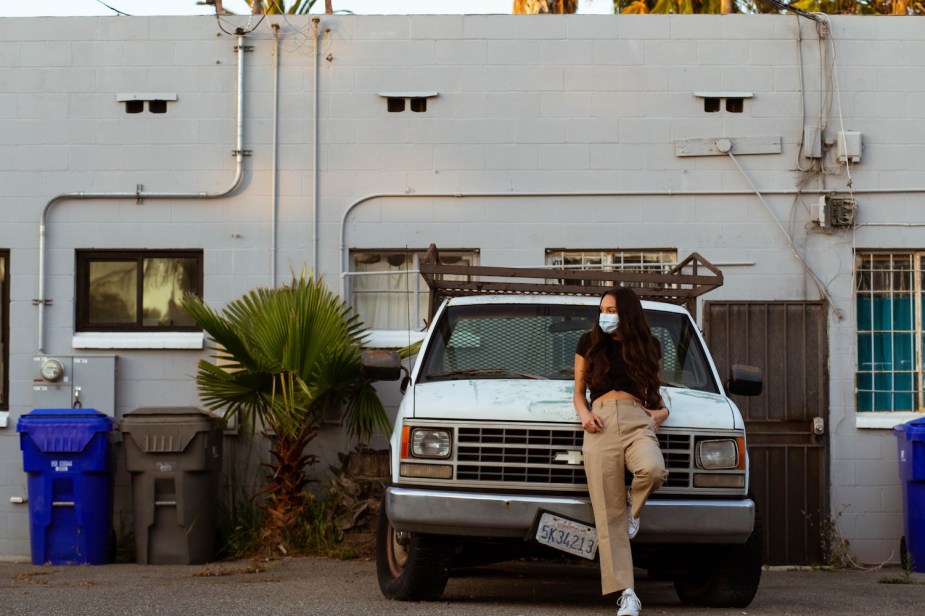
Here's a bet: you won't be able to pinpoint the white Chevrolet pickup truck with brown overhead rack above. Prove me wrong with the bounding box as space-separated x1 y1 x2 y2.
364 247 763 607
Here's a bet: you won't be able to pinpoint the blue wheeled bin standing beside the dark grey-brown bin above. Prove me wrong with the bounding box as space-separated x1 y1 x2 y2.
16 409 114 565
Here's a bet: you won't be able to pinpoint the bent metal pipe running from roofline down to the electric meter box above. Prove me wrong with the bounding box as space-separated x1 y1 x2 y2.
32 34 251 353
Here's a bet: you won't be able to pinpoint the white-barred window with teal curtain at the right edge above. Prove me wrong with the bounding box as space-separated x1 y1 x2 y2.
855 252 925 411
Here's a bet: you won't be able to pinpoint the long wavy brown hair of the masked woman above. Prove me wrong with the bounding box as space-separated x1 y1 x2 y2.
585 287 663 409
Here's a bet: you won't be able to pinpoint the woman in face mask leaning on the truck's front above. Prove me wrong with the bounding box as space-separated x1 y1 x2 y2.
574 288 668 616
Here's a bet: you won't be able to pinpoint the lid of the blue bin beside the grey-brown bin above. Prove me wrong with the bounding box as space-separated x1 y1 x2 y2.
16 408 115 453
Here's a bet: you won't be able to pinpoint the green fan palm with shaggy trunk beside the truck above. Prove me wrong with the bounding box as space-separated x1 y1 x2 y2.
184 272 389 546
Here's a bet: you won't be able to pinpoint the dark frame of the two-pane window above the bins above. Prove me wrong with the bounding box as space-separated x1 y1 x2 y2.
74 249 205 334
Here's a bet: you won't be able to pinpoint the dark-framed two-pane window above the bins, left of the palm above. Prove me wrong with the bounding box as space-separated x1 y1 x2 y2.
77 250 202 332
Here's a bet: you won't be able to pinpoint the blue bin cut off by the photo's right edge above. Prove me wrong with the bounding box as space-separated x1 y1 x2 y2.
893 417 925 573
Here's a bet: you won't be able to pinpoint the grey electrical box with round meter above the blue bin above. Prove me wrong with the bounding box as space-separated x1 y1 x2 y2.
32 355 116 417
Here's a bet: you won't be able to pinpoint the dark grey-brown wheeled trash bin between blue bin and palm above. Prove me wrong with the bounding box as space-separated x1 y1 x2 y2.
121 407 224 565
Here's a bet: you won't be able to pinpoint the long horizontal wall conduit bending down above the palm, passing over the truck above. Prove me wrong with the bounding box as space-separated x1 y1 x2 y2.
339 180 925 299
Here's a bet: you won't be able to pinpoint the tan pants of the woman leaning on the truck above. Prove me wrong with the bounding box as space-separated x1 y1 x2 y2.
581 400 668 595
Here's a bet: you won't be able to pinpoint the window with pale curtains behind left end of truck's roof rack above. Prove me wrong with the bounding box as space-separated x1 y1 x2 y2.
350 250 478 331
